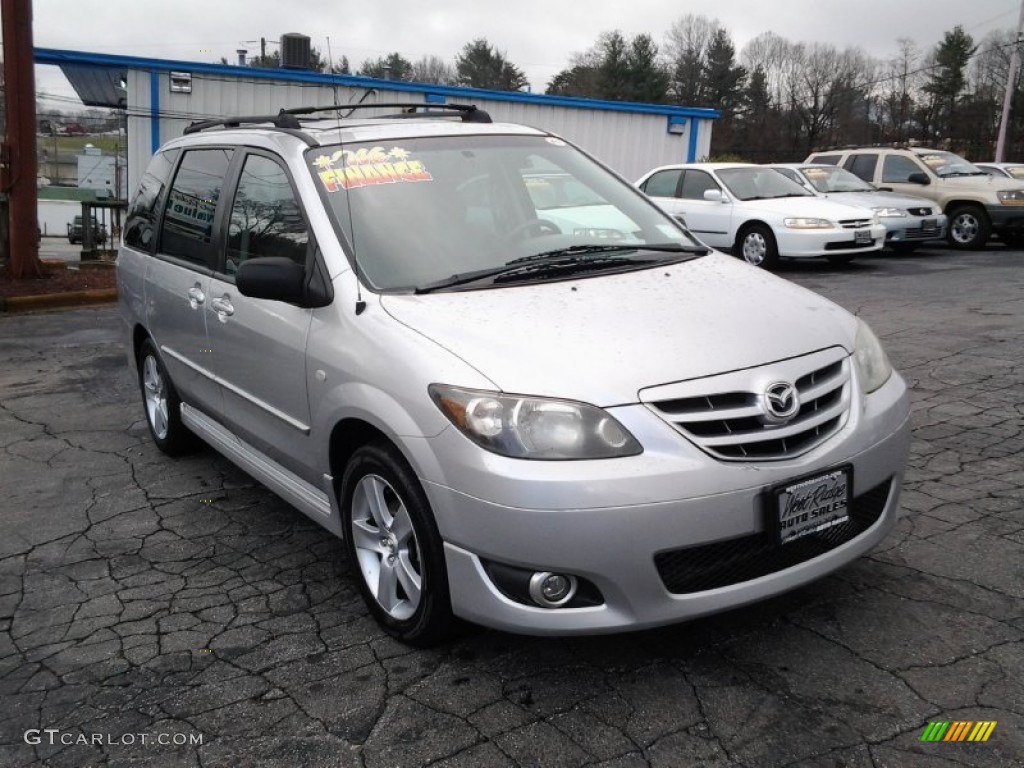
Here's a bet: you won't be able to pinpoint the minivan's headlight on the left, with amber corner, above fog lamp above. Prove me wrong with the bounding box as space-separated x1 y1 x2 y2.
429 384 643 460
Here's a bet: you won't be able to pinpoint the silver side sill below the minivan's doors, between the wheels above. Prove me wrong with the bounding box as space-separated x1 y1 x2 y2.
181 402 341 537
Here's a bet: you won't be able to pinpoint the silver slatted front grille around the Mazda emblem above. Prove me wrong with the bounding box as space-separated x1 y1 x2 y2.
641 349 852 461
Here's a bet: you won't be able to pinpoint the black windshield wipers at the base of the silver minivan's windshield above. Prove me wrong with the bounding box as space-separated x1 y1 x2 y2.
414 244 711 294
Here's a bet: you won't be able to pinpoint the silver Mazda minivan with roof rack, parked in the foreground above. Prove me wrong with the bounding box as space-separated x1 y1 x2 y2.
118 104 908 644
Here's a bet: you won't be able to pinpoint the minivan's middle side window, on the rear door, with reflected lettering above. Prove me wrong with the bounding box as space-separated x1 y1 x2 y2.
160 148 231 265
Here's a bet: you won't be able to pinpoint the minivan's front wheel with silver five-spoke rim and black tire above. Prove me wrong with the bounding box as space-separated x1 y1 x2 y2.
340 441 457 647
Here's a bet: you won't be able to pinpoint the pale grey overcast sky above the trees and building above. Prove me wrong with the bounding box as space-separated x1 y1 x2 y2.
28 0 1020 109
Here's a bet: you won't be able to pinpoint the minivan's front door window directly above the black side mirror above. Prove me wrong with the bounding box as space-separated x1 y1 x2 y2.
224 155 309 274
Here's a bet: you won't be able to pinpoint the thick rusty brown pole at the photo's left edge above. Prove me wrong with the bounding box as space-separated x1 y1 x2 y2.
0 0 42 280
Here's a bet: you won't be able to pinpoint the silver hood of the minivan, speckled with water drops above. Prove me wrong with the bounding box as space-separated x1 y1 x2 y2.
381 253 856 407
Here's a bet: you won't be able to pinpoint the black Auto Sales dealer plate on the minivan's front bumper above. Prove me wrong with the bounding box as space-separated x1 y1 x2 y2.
772 467 850 544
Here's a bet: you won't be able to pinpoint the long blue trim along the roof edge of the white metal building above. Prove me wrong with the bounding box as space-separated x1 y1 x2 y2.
35 48 721 120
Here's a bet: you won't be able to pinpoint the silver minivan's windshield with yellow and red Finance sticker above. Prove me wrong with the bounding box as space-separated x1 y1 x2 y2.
306 134 707 292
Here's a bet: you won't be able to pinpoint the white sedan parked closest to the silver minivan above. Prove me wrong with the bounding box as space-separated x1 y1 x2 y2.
636 163 886 268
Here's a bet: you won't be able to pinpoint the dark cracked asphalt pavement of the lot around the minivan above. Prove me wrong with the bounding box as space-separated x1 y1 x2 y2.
0 247 1024 768
